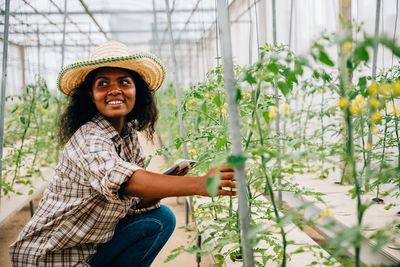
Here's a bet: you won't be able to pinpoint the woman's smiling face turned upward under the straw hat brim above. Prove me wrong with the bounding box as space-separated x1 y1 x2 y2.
91 68 136 132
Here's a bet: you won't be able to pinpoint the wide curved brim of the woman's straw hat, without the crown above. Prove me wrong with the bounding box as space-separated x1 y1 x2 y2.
57 53 165 96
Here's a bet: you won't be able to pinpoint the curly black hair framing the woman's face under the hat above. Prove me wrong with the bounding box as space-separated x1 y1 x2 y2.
58 68 158 146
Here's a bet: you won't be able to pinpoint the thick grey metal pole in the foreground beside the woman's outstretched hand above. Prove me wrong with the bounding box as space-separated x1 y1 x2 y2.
217 0 254 267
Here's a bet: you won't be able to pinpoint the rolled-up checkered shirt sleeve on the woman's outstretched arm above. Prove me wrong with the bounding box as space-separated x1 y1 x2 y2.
79 135 142 203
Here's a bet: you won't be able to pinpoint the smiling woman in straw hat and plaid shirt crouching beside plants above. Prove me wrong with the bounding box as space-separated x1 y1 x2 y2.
10 41 235 266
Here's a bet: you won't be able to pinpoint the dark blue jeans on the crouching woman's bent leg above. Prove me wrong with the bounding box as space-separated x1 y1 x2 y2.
88 205 175 267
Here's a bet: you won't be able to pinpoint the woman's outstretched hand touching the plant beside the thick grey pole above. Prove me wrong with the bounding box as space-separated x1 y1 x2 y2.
199 165 236 196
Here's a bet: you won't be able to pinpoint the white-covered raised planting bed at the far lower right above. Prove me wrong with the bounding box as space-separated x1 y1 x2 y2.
275 173 400 266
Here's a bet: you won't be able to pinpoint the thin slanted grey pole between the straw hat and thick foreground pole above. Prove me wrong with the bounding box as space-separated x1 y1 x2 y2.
165 0 188 159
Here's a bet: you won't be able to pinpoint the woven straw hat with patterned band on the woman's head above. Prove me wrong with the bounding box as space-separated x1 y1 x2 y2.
57 41 165 95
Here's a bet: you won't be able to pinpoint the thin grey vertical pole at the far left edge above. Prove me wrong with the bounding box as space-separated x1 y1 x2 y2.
0 0 10 201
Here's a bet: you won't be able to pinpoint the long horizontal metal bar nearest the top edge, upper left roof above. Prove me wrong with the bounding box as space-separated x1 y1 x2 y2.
0 8 215 16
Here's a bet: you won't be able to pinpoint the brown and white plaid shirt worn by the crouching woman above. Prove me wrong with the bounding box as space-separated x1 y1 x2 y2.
10 114 160 266
